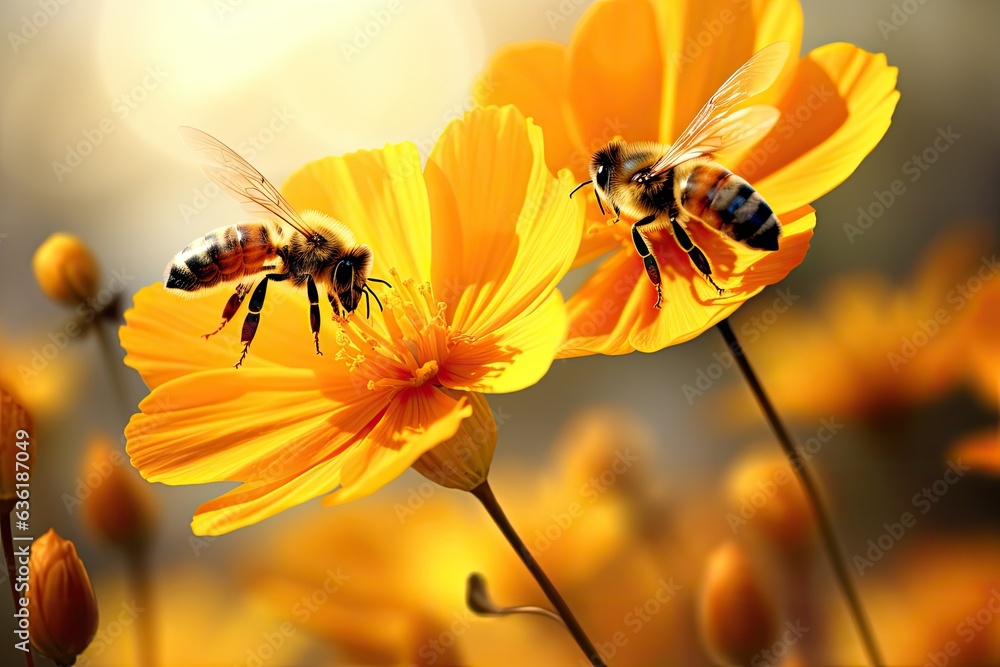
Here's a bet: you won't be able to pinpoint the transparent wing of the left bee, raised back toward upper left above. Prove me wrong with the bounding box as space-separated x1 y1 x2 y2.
177 127 314 237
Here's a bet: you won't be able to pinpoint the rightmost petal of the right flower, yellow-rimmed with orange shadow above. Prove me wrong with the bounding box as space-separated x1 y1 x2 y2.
734 44 899 212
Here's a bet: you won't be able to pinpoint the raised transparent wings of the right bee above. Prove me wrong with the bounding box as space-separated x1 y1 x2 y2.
652 42 791 174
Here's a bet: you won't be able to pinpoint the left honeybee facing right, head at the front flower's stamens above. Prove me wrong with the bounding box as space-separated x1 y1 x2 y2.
164 127 391 368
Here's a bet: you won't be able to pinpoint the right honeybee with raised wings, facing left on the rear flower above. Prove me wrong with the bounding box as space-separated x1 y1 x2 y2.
571 42 789 308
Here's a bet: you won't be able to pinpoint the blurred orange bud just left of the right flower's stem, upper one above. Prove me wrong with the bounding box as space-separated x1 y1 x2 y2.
726 452 812 552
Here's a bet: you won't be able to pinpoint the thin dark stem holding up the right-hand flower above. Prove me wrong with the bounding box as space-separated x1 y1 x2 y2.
716 319 885 666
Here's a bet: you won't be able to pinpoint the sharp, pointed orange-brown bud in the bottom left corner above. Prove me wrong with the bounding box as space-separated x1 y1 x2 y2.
26 530 97 665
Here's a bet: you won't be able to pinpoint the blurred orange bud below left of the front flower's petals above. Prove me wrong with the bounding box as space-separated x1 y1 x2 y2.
80 436 158 550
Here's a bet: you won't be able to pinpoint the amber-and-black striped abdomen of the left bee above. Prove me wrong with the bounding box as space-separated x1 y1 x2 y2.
165 222 277 292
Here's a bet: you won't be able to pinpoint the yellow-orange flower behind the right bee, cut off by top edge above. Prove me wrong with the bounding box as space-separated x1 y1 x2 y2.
480 0 899 356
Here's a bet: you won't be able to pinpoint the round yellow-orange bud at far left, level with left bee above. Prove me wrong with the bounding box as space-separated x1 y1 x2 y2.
31 234 99 306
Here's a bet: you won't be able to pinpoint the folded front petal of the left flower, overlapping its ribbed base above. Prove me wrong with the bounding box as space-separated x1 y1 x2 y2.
323 384 472 505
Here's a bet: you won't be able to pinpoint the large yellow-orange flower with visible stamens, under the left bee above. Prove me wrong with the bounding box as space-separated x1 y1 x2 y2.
121 107 584 534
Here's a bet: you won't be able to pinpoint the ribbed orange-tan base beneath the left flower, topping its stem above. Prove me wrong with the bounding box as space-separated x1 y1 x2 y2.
413 392 497 491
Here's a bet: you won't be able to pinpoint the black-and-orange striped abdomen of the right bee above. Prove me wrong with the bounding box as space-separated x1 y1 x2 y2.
709 173 781 250
